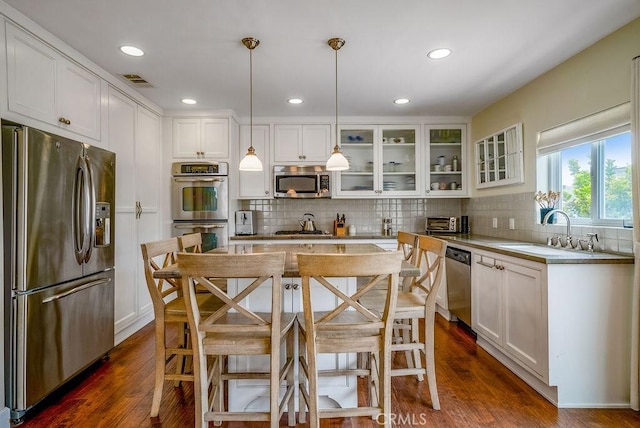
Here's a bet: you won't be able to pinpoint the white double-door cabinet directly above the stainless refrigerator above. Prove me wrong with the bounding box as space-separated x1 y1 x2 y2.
6 23 102 141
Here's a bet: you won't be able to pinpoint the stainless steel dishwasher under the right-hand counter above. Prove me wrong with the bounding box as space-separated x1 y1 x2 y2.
445 247 473 331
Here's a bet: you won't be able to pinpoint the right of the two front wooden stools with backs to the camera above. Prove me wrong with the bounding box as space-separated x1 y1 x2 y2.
297 251 402 427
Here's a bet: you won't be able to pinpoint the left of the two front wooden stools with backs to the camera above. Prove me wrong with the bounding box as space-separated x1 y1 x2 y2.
178 252 295 427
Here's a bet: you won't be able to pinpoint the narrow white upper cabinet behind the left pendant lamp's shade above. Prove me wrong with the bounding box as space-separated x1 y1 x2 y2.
238 125 272 199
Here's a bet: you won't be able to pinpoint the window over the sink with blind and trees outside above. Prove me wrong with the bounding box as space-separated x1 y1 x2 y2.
538 104 633 226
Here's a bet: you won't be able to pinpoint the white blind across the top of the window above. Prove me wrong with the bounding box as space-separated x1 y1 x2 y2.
537 103 631 155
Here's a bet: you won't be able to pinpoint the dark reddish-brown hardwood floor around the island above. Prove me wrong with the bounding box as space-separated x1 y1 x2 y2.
15 316 640 428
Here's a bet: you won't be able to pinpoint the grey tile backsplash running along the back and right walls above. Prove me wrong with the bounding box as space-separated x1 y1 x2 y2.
241 192 633 254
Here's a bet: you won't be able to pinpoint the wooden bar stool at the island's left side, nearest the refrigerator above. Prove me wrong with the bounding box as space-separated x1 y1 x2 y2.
140 238 222 417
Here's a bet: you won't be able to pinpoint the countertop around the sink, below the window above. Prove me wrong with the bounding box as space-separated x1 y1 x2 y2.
438 235 634 264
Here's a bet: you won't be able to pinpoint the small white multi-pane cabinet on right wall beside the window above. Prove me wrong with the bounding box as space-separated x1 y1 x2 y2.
475 123 524 189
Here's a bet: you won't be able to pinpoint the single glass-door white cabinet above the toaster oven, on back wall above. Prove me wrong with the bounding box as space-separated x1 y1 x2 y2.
425 125 468 198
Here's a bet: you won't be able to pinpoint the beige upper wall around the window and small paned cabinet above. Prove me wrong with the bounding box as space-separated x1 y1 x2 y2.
469 19 640 197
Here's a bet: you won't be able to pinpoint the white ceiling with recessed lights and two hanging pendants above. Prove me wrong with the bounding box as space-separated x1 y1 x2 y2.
5 0 640 117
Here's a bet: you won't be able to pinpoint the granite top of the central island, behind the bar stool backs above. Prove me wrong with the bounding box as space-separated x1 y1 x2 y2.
153 243 420 279
